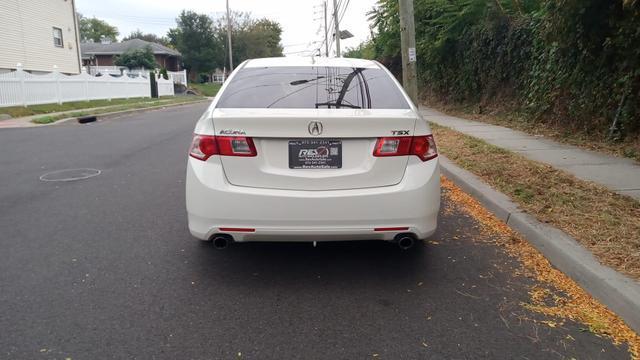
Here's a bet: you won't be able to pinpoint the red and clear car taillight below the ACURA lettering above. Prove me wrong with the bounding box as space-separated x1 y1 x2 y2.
189 134 258 161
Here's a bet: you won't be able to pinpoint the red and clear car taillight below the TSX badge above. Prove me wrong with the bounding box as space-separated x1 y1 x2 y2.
373 135 438 161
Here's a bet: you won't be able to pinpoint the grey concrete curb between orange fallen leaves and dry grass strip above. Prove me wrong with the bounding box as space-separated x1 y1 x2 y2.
439 155 640 332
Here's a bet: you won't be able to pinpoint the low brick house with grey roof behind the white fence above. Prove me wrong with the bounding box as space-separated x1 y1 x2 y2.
80 39 182 71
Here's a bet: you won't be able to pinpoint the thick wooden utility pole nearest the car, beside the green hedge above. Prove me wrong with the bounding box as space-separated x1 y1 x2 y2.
398 0 418 105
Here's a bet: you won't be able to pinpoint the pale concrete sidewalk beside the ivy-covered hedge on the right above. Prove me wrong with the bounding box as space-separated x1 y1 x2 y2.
420 106 640 200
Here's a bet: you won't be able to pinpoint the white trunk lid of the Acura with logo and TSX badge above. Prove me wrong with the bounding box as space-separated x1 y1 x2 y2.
212 108 416 190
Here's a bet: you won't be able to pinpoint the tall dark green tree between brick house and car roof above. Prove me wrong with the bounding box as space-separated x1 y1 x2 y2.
167 10 224 79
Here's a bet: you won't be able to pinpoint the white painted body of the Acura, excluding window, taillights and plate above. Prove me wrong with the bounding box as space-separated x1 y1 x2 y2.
186 58 440 242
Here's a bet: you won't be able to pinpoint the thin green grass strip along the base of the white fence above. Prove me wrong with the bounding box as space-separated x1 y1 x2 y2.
0 96 186 118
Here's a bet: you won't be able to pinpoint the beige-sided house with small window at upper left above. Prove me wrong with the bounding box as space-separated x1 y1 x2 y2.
0 0 81 74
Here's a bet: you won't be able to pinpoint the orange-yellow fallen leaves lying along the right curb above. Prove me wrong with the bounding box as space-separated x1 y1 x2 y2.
442 177 640 360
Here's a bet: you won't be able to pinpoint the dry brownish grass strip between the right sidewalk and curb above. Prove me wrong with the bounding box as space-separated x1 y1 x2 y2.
431 124 640 280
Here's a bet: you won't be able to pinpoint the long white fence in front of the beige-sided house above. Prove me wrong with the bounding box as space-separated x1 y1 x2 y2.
0 64 174 107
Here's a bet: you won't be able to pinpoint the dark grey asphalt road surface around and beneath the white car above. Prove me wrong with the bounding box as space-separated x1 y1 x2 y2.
0 104 628 359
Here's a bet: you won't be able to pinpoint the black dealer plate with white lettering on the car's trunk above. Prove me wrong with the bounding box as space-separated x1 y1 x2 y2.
289 139 342 169
